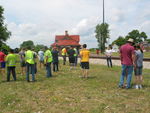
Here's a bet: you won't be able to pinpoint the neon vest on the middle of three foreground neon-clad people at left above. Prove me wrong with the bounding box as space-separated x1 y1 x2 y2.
25 50 34 64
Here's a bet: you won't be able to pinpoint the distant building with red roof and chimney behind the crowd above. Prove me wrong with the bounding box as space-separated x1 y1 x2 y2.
51 31 80 49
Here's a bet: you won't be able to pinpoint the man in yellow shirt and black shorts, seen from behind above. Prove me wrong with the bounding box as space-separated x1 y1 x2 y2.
80 44 90 78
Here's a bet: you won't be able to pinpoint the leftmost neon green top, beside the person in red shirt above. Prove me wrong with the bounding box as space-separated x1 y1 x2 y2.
6 53 17 67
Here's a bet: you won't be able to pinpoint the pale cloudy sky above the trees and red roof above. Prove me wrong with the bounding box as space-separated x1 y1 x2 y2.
0 0 150 48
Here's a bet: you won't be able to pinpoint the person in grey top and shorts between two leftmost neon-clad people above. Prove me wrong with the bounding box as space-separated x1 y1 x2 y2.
19 48 26 75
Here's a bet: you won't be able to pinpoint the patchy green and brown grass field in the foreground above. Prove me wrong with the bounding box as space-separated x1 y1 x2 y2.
0 61 150 113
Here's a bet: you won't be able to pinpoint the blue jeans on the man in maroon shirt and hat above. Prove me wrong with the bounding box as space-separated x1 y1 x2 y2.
119 64 133 88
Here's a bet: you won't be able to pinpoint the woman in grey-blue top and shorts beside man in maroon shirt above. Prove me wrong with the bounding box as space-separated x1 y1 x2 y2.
134 45 143 89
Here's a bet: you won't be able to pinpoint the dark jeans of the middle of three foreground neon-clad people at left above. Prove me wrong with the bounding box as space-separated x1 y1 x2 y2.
26 63 35 81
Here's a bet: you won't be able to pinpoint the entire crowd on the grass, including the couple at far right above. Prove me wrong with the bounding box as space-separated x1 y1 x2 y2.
0 39 143 89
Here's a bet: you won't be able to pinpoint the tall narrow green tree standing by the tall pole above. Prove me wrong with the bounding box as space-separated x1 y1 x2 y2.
95 23 109 53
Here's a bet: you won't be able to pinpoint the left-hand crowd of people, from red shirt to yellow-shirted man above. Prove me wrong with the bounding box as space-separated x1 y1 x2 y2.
0 44 90 82
